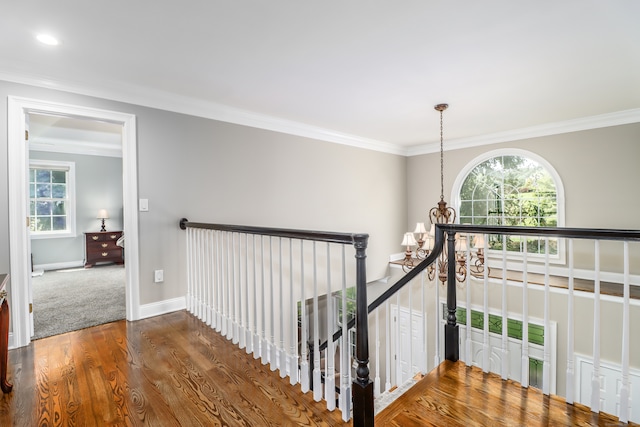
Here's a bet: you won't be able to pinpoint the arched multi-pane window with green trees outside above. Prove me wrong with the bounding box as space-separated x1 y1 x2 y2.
452 149 564 256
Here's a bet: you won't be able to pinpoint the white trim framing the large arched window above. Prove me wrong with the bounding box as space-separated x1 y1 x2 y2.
450 148 566 264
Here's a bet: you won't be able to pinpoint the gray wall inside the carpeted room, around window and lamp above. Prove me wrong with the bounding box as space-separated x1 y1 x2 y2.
29 151 123 265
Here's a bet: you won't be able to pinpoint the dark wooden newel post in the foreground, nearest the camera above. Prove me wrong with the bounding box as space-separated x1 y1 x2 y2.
352 234 374 427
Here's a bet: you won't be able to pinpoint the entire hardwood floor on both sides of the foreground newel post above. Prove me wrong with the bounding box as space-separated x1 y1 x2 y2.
0 311 632 427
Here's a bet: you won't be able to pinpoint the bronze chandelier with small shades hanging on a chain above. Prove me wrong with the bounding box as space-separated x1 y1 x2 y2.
401 104 489 284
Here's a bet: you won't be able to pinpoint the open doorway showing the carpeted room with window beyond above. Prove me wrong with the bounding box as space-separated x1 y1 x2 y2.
27 113 126 339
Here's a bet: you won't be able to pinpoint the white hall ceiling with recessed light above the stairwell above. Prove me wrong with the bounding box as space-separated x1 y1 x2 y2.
0 0 640 154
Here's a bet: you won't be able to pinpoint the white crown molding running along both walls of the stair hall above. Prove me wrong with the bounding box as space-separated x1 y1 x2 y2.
0 70 640 157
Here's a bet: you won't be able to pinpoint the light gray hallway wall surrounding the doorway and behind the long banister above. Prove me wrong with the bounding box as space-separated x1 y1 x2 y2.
0 81 407 310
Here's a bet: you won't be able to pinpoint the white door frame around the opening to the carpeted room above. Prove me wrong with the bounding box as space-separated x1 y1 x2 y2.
8 96 140 348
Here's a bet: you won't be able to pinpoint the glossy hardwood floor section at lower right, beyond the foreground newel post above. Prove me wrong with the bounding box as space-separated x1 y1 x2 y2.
376 361 637 427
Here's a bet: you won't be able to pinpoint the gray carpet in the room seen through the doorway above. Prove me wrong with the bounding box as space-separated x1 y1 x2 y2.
32 264 126 339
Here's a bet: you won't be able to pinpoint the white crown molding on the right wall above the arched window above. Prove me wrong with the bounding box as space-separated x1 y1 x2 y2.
406 108 640 157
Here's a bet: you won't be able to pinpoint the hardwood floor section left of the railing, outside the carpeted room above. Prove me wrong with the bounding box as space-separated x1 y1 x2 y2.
0 311 350 427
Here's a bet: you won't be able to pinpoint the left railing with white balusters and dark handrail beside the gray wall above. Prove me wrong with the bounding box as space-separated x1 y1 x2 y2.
181 220 366 421
